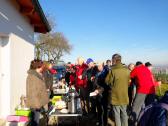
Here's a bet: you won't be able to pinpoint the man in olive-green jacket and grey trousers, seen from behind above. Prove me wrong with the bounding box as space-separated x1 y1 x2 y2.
106 54 130 126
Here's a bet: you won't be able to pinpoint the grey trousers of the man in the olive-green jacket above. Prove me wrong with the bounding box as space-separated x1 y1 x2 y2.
113 105 128 126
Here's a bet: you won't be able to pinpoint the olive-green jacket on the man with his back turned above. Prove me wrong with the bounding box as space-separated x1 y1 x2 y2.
106 64 130 105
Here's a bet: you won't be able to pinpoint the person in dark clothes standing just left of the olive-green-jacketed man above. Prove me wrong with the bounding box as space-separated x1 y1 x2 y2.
91 62 109 126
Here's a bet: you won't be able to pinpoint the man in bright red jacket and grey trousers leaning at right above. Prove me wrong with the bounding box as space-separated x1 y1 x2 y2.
130 63 160 121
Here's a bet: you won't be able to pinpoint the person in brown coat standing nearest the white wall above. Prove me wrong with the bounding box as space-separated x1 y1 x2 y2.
26 60 49 126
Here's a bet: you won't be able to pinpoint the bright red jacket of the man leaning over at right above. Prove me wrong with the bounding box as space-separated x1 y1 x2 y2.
130 65 157 94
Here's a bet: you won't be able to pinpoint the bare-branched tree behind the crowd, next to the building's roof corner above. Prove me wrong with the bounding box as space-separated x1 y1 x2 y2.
36 32 72 63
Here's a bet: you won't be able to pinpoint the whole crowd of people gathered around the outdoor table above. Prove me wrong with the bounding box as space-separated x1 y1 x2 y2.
27 54 161 126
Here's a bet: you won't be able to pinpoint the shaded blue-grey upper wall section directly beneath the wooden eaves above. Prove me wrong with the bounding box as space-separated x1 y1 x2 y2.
0 0 34 43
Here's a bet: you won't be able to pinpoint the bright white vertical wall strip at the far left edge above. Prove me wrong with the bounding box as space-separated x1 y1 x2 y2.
0 37 11 117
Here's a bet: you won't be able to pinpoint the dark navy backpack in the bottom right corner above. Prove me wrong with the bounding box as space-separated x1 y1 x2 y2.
138 102 168 126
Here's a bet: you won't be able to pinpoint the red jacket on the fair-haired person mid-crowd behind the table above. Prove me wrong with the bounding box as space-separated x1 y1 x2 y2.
76 64 87 87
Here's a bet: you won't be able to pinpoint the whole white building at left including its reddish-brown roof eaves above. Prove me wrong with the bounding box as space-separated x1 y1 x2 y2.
0 0 50 118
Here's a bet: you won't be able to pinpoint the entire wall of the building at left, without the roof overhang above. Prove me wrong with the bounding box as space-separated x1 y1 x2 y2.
0 0 34 117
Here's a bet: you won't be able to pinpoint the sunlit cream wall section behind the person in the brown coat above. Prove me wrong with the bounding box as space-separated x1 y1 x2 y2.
10 34 34 113
